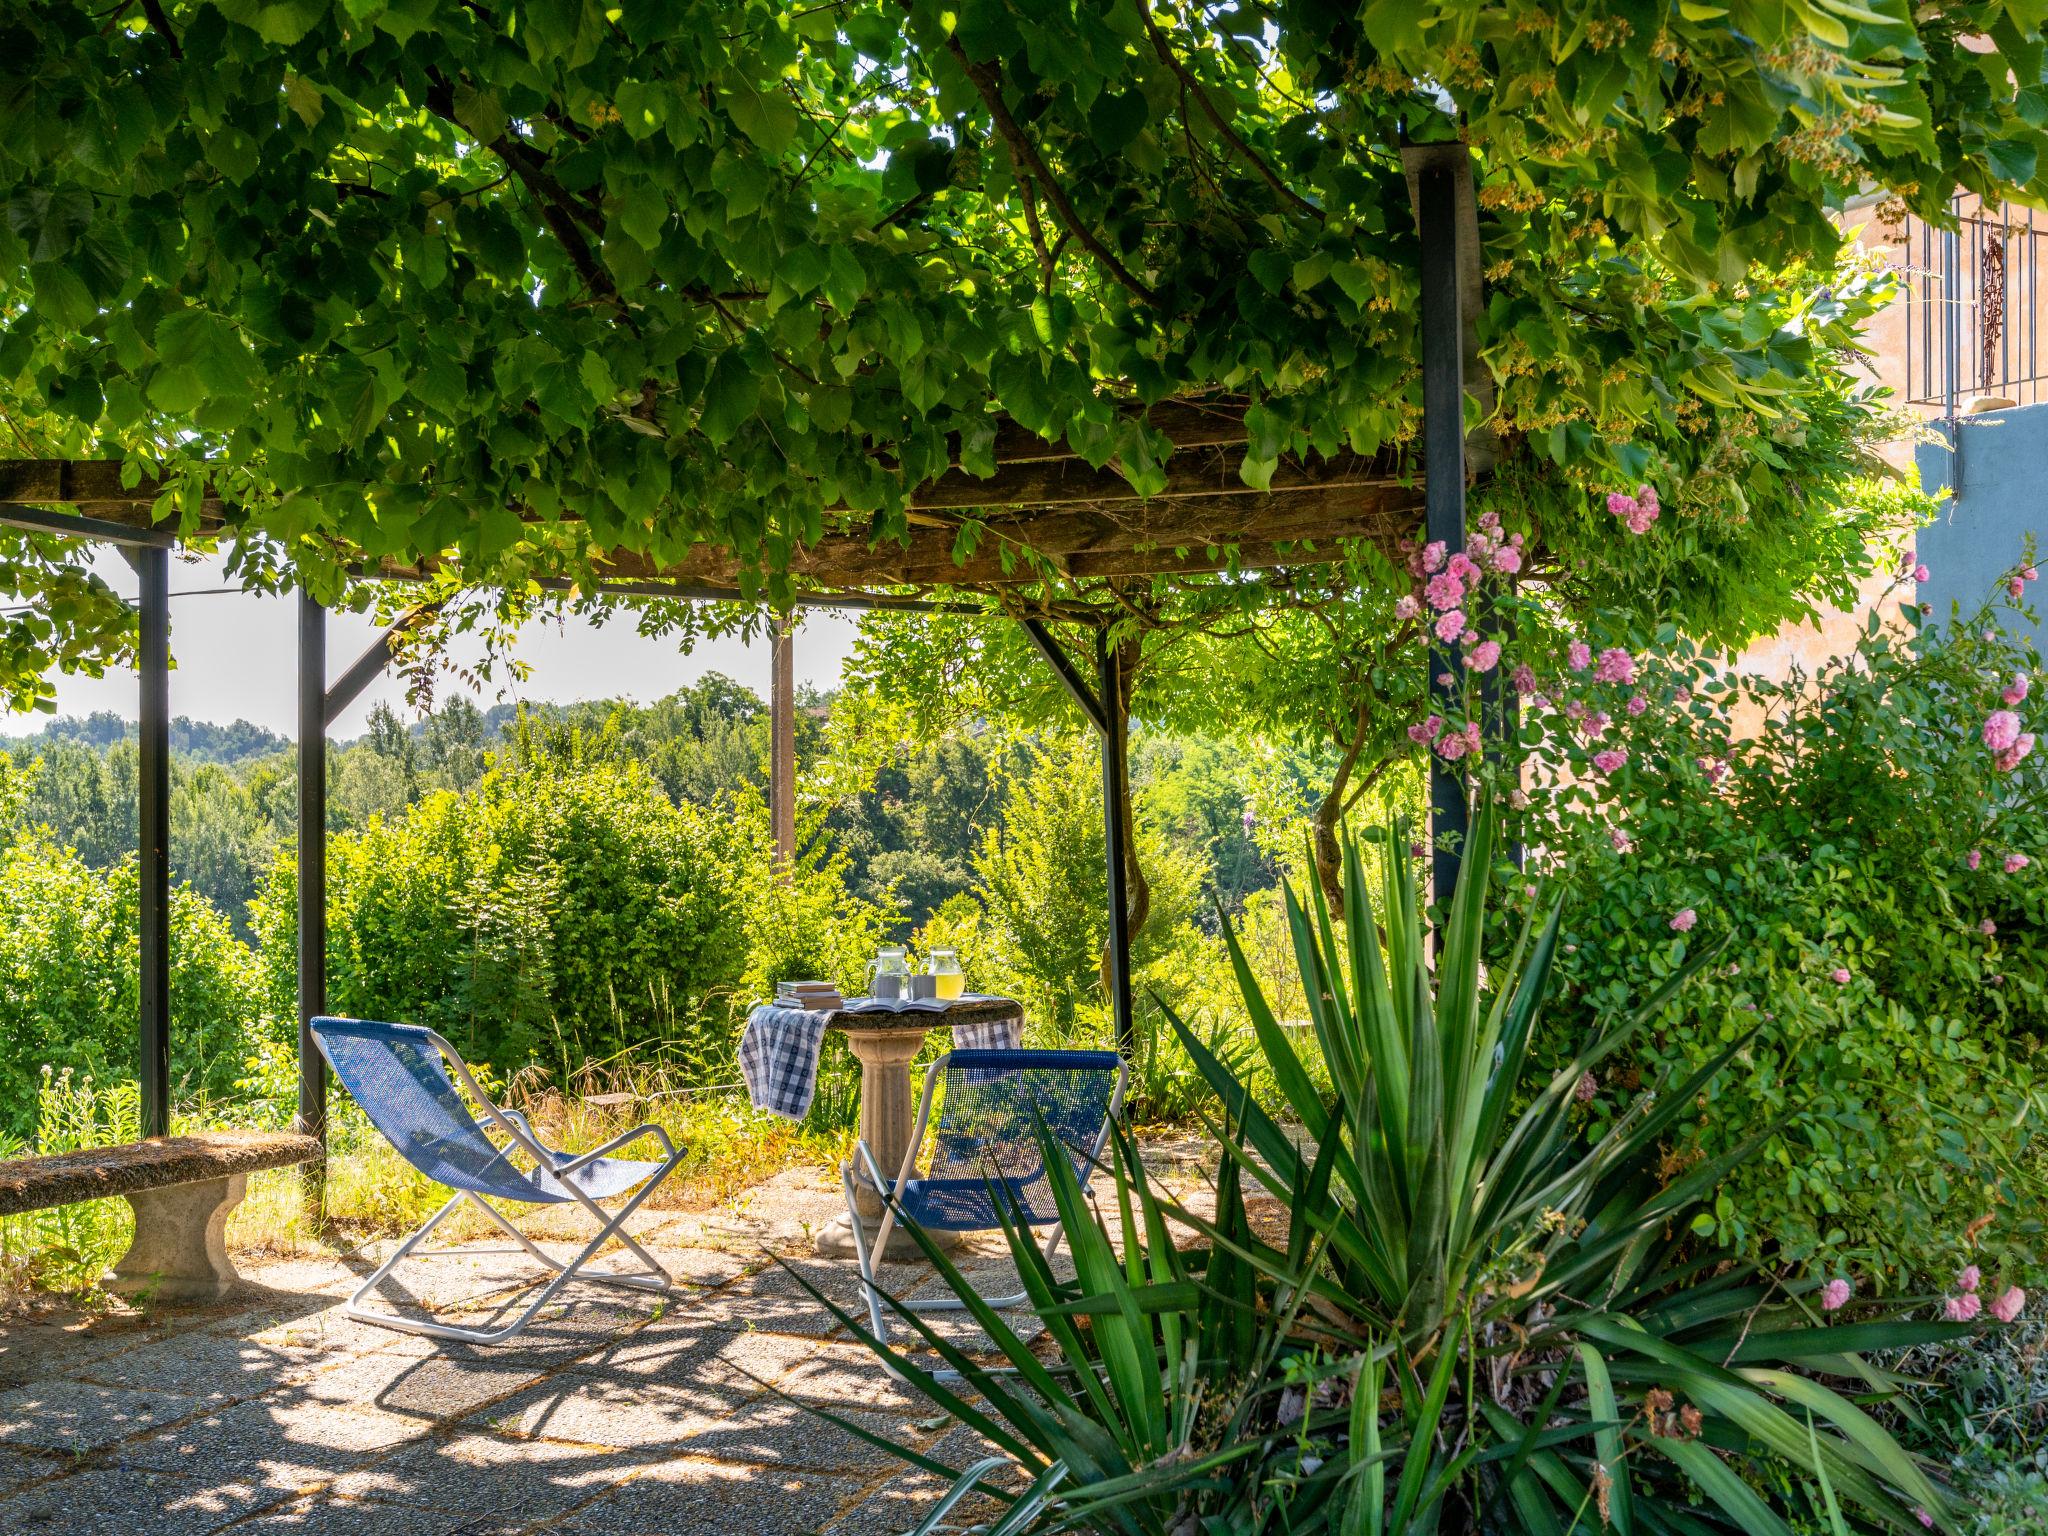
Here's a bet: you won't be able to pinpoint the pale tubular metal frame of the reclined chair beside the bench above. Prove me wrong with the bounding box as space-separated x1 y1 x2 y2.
313 1030 682 1343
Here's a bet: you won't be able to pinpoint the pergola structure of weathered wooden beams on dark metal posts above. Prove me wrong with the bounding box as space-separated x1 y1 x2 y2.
0 145 1485 1179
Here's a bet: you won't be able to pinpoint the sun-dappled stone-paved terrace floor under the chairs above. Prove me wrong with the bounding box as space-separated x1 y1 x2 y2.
0 1149 1192 1536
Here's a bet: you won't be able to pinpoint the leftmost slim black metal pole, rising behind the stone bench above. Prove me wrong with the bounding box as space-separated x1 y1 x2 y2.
135 549 170 1137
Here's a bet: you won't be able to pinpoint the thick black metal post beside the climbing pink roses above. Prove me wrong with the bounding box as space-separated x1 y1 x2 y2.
1417 150 1470 901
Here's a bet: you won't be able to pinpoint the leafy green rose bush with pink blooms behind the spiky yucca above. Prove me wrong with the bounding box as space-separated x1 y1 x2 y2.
1530 577 2048 1288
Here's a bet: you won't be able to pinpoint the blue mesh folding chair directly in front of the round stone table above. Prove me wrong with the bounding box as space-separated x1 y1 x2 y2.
840 1051 1130 1343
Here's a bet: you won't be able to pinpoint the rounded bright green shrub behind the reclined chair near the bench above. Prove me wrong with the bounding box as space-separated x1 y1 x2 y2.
256 762 760 1071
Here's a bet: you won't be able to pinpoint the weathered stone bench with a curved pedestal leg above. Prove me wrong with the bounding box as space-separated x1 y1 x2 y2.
0 1130 326 1300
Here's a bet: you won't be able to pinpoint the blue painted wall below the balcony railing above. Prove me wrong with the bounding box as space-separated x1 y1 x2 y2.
1915 406 2048 645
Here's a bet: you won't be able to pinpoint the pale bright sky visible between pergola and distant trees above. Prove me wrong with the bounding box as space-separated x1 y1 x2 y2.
46 549 858 739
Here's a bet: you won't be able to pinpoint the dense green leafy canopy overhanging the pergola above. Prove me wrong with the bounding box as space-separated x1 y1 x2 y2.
0 0 2044 700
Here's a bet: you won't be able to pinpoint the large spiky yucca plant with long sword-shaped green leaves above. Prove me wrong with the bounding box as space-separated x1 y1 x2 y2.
819 813 1970 1536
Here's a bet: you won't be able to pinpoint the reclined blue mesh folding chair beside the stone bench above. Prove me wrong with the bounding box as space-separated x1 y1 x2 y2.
313 1018 682 1343
